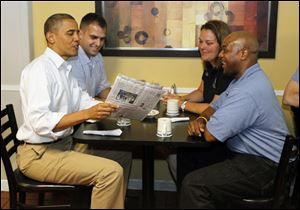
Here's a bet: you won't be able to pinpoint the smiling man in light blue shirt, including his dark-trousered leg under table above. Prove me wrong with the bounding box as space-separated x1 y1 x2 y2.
68 13 132 190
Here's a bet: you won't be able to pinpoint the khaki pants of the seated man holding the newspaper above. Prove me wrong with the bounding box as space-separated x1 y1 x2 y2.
17 139 125 209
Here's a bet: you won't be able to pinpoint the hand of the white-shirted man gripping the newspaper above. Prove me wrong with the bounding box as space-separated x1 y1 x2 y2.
87 103 119 120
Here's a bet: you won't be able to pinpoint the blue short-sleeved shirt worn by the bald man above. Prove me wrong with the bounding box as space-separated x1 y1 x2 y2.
207 64 288 163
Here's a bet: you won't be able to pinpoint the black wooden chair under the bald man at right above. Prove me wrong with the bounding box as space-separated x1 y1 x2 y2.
239 135 299 209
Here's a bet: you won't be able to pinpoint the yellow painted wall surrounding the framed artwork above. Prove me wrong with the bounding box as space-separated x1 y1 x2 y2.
32 1 299 90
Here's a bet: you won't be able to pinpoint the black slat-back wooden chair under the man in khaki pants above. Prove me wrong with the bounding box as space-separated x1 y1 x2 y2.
1 104 91 209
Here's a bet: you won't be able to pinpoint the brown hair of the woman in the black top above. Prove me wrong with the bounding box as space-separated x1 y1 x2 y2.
200 20 231 68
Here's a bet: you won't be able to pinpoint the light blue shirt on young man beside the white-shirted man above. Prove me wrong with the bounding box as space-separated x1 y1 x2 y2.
68 46 110 97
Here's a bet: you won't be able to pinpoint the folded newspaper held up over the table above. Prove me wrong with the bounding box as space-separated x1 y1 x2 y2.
106 75 165 120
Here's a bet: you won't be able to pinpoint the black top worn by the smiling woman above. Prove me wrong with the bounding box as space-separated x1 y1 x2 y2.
202 65 233 103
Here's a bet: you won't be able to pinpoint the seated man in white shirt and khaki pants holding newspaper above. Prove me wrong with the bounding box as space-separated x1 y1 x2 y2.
17 14 125 209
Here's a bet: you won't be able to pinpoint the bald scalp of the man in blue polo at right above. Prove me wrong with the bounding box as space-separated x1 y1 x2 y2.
225 31 259 59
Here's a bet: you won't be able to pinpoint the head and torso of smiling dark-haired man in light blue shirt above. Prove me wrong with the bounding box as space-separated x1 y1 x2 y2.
68 13 110 100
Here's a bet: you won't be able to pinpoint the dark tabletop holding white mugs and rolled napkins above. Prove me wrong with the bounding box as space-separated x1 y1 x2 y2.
73 105 210 147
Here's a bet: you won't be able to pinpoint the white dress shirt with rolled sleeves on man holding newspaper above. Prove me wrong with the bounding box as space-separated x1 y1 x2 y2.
17 48 99 143
